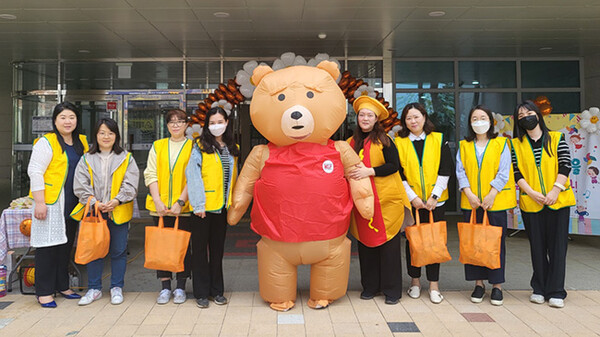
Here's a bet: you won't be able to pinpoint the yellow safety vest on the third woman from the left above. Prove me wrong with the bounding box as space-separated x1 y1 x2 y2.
146 138 192 213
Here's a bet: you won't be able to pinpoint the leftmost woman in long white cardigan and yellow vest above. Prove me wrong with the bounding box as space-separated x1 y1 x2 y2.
27 102 88 308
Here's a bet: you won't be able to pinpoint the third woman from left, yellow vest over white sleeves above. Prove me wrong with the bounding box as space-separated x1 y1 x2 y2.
144 109 192 304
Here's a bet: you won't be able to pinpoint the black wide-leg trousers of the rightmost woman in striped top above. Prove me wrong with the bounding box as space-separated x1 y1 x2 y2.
521 207 570 300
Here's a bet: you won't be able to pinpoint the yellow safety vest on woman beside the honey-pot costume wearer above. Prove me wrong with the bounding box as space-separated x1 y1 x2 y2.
394 132 448 202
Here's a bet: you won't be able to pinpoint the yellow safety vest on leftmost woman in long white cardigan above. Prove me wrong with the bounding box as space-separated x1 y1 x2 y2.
29 132 89 205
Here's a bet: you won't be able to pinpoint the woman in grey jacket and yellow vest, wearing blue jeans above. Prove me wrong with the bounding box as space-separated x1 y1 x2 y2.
71 118 140 305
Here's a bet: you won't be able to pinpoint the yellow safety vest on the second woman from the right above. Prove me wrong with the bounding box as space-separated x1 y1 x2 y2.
460 137 517 211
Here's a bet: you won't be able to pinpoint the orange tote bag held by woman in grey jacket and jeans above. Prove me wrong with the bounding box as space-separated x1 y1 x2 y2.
75 197 110 264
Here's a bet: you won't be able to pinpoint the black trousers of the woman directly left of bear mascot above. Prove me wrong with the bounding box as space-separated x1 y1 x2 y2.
192 209 227 298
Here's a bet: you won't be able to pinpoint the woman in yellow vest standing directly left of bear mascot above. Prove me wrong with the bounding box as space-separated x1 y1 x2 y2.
186 107 240 308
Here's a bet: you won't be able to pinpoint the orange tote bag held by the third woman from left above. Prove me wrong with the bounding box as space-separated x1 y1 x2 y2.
144 217 191 273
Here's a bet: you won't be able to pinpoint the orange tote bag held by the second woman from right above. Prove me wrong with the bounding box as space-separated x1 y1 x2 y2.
457 209 502 269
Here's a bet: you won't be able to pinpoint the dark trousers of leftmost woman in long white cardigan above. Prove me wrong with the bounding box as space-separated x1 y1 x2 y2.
35 217 79 296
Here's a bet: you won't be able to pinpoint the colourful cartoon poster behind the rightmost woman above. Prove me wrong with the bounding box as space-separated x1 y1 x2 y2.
494 108 600 235
